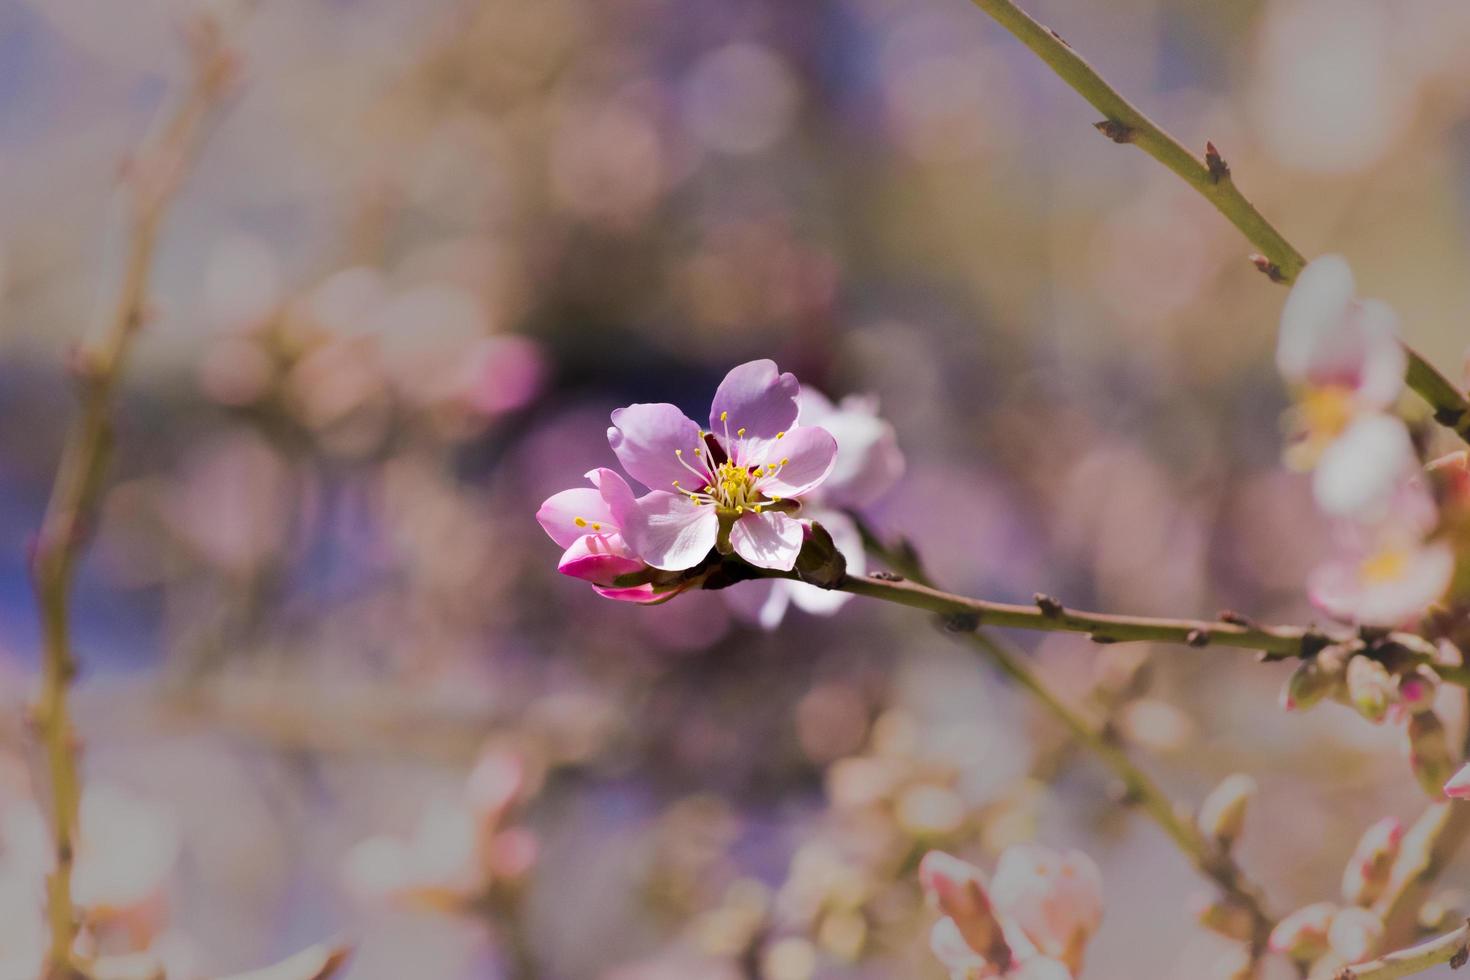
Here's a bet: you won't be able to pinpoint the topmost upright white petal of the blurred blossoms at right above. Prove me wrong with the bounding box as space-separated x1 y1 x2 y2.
1276 256 1360 383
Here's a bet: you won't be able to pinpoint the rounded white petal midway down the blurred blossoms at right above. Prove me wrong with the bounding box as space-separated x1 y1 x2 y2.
1311 414 1419 519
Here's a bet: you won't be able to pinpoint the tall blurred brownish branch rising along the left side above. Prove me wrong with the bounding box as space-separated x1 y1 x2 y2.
32 22 232 979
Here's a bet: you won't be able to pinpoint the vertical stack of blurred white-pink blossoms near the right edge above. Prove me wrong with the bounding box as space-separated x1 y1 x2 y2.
1276 256 1454 626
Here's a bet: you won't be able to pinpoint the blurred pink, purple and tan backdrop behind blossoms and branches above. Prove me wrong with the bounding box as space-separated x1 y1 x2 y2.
0 0 1470 980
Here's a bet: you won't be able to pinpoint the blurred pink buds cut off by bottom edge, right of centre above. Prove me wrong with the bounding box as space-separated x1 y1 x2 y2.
919 843 1103 980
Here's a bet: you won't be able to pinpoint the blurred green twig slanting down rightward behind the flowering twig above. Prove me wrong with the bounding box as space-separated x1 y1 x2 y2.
854 516 1274 955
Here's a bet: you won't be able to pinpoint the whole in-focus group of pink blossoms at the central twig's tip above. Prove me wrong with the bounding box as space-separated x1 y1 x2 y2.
537 360 903 605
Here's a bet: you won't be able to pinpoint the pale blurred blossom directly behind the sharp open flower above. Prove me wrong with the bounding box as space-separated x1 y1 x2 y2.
725 386 904 629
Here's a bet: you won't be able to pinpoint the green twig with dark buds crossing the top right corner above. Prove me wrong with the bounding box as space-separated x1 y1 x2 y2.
972 0 1470 442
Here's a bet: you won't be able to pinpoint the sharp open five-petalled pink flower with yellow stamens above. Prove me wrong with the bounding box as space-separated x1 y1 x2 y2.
607 360 836 572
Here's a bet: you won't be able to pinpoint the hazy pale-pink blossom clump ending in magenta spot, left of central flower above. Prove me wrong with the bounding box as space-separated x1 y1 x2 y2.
200 238 545 455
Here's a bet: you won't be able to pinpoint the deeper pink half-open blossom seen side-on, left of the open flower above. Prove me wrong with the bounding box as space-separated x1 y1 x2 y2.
537 467 669 602
